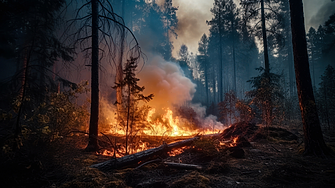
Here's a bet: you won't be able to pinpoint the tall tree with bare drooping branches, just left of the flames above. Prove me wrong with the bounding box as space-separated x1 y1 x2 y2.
69 0 141 151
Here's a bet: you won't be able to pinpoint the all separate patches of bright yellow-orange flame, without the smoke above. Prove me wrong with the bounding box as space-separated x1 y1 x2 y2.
97 105 221 158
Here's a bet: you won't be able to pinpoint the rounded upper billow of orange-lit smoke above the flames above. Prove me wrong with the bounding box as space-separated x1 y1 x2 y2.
138 56 196 109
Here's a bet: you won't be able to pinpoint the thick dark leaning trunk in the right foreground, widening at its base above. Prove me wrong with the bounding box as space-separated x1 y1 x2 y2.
290 0 331 156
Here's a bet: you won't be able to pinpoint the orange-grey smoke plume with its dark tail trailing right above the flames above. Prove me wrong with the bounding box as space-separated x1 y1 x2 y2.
138 56 223 129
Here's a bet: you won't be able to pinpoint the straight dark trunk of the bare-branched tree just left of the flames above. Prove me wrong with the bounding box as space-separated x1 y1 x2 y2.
85 0 99 151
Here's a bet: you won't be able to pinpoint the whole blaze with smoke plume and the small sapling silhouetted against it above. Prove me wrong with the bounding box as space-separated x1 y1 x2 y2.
97 57 224 157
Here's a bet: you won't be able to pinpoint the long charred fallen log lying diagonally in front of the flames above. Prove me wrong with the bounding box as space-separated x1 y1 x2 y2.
90 136 200 172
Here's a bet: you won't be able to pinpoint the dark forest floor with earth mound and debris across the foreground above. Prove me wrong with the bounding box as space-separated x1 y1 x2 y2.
2 123 335 188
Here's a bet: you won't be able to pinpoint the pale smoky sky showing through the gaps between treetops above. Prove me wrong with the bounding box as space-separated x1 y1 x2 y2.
169 0 335 57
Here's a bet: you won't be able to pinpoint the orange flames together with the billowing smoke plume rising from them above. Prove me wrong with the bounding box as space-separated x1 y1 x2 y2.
98 57 224 157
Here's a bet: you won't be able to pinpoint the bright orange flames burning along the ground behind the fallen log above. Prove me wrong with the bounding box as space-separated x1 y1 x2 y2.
97 108 224 158
